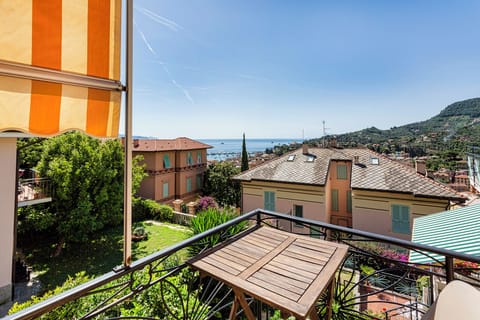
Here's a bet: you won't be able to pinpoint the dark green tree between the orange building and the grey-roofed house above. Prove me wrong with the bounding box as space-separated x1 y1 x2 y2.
203 161 240 207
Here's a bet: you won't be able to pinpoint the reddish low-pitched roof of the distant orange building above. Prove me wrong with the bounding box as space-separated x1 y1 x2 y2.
133 137 213 151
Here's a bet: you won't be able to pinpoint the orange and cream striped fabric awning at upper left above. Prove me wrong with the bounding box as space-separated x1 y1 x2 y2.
0 0 122 137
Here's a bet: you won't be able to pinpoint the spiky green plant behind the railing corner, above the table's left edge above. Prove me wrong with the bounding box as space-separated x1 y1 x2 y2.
189 208 247 256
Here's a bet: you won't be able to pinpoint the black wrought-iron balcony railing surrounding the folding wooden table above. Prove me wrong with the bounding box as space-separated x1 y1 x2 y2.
7 209 480 320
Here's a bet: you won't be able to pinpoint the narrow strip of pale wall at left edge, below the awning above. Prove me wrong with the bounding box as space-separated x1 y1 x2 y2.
0 137 17 303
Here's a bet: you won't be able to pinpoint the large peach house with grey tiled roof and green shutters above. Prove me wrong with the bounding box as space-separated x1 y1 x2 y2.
234 146 465 239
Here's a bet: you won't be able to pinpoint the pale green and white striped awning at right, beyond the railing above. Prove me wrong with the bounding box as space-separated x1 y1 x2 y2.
409 204 480 263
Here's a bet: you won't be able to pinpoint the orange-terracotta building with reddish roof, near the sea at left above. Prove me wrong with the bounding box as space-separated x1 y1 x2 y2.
133 137 212 202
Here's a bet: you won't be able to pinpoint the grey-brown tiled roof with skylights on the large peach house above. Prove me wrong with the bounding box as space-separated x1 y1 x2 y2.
235 148 462 199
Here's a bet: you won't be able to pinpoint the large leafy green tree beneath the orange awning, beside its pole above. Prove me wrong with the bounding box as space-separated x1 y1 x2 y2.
37 132 144 248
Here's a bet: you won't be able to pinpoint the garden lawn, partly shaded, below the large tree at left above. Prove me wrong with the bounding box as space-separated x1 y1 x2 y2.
21 222 190 290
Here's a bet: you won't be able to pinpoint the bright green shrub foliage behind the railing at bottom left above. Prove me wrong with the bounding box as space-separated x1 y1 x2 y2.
9 270 209 320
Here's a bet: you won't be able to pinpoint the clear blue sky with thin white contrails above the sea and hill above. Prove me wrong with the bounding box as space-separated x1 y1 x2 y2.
126 0 480 139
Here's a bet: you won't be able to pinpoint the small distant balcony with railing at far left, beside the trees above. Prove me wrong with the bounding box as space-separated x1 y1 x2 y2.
17 178 52 207
